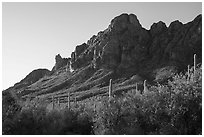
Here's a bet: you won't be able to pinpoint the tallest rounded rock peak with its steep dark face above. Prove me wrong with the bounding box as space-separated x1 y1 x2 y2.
69 14 149 69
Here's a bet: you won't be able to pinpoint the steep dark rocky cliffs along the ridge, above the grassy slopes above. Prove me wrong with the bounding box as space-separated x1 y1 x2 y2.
52 14 202 77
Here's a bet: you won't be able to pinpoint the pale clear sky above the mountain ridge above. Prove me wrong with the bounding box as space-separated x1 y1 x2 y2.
2 2 202 89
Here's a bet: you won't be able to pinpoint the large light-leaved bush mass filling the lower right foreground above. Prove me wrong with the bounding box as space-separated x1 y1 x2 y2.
94 67 202 135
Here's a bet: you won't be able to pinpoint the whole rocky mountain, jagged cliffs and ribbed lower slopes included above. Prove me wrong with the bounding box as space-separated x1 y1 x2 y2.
3 14 202 99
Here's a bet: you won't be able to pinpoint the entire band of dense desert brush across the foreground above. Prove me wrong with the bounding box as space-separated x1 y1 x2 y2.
2 66 202 135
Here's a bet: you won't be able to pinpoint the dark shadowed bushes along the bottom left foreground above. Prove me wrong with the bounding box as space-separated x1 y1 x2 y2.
2 101 93 135
